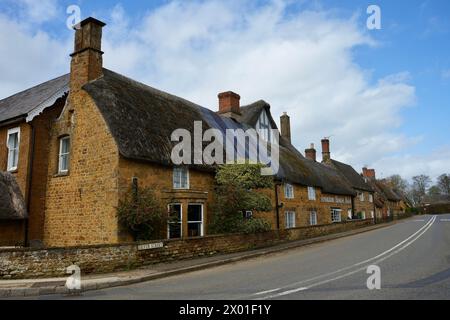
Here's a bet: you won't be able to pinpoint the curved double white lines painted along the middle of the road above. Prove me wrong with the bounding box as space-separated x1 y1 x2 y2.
257 216 437 300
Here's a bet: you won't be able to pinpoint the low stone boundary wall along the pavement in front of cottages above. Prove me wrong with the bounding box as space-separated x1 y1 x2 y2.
0 220 373 279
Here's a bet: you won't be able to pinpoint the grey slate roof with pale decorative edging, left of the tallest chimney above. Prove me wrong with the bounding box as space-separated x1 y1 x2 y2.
0 74 70 123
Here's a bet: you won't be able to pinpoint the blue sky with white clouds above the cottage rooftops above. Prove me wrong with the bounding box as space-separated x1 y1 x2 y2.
0 0 450 179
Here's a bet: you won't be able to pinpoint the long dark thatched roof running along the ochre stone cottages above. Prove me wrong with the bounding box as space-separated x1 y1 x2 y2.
83 69 354 195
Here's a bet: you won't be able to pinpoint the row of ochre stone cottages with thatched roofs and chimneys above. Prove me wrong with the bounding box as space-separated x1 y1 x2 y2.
0 18 386 247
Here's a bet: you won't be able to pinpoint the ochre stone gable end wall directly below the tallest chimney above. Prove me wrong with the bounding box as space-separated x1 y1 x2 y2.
44 91 120 247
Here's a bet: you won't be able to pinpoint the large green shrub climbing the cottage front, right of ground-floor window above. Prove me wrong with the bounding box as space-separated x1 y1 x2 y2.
210 164 274 234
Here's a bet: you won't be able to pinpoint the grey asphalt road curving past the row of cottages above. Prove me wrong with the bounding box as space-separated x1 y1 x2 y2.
41 214 450 300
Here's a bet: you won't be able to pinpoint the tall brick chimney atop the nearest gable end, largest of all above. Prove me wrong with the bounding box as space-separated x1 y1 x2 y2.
70 18 106 92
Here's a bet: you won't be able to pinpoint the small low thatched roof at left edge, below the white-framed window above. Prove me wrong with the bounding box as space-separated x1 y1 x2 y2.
0 171 28 220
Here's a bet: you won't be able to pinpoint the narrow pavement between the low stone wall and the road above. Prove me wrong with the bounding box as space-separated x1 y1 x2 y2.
0 221 399 299
